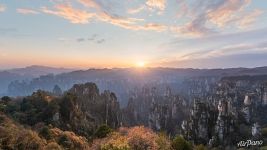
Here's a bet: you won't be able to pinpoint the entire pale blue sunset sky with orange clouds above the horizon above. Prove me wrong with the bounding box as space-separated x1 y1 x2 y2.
0 0 267 69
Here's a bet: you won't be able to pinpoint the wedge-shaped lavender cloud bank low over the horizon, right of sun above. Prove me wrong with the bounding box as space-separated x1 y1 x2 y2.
157 40 267 68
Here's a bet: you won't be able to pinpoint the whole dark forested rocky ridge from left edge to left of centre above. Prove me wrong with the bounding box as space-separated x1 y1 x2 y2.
0 83 121 137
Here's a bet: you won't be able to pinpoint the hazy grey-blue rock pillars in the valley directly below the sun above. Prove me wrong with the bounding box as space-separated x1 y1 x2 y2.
123 87 188 134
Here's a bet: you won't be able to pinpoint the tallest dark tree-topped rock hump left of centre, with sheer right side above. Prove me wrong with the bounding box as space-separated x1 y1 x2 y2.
58 83 121 137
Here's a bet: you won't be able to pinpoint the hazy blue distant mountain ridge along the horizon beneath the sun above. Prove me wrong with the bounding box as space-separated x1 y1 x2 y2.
4 67 267 105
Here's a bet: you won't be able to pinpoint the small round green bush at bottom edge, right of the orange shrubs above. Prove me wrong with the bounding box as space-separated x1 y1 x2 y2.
171 136 193 150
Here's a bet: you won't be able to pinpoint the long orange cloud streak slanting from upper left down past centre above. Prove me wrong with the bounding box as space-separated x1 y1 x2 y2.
42 0 167 31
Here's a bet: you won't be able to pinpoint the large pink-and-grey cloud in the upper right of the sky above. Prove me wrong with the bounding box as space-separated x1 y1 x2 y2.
171 0 263 36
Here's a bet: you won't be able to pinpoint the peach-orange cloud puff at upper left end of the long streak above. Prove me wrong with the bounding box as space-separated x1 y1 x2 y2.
42 4 95 24
